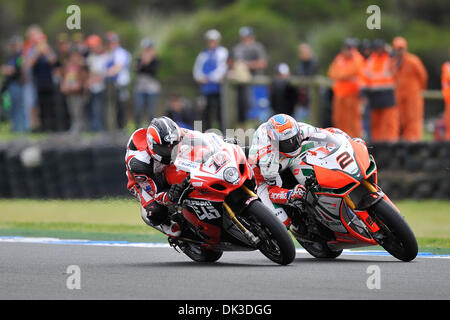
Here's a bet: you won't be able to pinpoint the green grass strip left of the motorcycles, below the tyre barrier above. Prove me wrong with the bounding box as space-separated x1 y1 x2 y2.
0 199 166 242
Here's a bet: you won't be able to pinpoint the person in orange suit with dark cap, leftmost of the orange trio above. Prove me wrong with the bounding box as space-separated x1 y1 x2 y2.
328 41 362 138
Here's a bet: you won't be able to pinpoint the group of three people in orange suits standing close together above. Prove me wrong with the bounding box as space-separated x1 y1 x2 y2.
328 37 428 142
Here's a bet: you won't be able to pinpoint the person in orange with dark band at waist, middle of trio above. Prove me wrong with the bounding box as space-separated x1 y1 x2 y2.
362 39 399 142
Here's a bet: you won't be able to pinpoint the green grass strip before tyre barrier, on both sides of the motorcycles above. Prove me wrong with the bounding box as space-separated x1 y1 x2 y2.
0 199 450 253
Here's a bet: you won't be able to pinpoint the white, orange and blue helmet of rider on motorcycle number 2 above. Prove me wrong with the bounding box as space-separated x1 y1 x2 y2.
267 113 303 158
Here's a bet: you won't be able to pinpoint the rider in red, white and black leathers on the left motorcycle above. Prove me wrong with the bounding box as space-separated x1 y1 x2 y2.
125 117 189 237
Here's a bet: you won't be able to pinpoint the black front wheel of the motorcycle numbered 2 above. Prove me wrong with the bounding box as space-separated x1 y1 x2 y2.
369 199 418 262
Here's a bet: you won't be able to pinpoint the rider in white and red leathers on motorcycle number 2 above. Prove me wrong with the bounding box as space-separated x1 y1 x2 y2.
248 114 364 227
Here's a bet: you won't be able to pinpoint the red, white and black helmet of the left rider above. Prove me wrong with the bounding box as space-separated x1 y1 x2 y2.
147 117 181 164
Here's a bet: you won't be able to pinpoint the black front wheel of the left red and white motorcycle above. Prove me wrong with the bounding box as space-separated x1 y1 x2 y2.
244 201 295 265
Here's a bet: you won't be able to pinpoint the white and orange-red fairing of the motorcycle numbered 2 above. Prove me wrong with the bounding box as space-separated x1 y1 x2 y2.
298 132 376 245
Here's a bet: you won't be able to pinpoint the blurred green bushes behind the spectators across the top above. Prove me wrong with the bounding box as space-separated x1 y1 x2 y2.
0 0 450 88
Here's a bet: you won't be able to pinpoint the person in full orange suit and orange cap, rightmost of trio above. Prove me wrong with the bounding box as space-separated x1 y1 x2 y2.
392 37 428 142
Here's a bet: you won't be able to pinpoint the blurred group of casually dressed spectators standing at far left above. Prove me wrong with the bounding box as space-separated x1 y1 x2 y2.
1 25 160 133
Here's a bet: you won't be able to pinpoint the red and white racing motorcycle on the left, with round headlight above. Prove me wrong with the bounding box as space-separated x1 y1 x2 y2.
166 132 295 265
